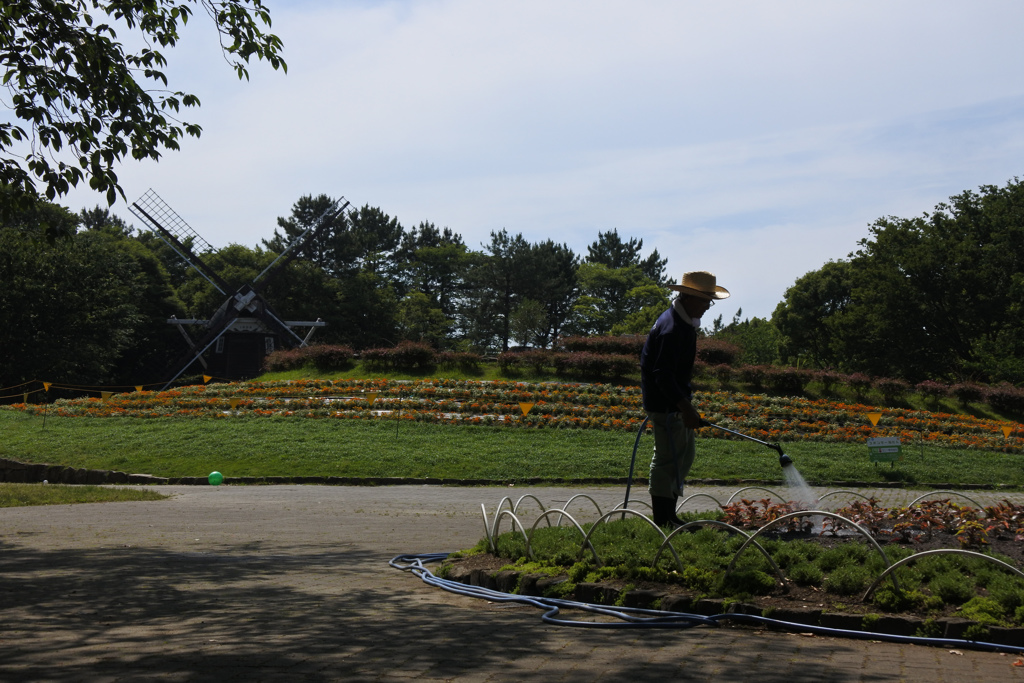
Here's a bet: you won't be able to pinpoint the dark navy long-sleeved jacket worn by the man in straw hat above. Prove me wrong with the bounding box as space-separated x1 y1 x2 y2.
640 307 697 413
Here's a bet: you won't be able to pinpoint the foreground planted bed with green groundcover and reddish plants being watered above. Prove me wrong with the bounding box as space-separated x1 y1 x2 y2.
454 499 1024 644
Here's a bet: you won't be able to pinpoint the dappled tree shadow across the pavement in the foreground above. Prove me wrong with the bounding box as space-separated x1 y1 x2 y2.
0 540 948 683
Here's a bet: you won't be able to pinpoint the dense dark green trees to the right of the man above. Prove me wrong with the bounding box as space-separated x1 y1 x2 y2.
772 178 1024 384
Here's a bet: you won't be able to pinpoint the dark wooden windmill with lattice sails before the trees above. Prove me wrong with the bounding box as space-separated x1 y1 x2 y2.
129 189 349 389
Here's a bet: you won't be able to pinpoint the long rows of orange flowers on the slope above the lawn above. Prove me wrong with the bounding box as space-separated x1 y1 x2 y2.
11 380 1022 453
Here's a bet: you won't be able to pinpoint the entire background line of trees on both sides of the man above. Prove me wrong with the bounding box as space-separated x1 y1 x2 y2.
0 178 1024 386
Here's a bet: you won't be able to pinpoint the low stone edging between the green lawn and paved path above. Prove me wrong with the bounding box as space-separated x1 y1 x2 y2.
0 458 1021 490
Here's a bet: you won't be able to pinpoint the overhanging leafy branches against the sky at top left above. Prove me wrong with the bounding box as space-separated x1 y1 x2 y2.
0 0 288 208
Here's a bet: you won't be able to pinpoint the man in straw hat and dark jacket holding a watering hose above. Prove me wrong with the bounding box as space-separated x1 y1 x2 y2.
640 270 729 526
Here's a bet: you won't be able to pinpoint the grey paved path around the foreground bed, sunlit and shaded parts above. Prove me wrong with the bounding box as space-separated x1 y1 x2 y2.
0 485 1024 683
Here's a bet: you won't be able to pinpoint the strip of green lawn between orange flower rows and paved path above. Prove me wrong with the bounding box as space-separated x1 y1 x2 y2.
0 411 1024 487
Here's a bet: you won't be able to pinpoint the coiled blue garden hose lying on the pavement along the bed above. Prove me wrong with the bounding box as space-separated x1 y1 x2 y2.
388 553 1024 655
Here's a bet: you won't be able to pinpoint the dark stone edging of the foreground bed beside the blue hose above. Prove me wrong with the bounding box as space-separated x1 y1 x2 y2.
445 562 1024 647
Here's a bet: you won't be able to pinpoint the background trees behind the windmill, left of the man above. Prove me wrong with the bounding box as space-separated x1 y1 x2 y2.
0 189 669 386
